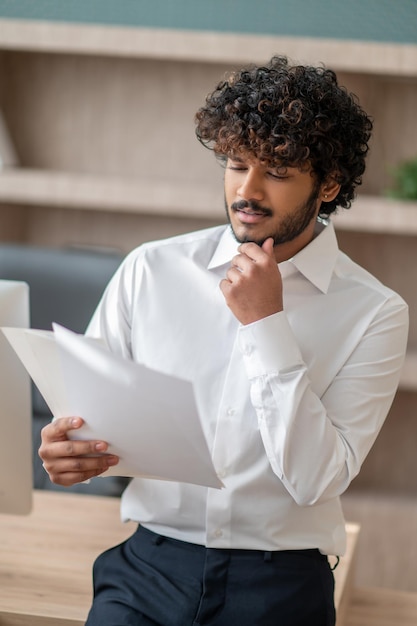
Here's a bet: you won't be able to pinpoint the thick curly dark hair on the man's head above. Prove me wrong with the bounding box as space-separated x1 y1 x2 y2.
196 56 372 216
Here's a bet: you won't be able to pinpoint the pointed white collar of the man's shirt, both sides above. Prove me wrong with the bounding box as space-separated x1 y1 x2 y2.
208 220 339 293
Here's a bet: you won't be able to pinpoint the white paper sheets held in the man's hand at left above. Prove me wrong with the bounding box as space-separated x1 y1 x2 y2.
2 325 223 488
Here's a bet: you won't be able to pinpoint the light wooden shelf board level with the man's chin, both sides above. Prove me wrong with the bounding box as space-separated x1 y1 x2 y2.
0 168 417 235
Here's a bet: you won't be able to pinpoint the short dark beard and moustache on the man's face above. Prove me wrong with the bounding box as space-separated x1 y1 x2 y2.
226 184 320 246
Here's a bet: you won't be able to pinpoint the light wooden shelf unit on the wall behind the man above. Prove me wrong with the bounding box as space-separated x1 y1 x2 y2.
0 19 417 584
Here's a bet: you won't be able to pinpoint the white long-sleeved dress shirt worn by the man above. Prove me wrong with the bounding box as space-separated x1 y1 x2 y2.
88 219 408 555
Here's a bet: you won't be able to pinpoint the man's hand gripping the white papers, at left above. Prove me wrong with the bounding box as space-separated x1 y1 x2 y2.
39 417 119 487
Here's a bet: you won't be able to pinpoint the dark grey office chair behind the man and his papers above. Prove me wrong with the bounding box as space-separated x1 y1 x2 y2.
0 243 127 496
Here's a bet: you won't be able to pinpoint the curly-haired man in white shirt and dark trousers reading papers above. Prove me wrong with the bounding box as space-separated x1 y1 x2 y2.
40 58 408 626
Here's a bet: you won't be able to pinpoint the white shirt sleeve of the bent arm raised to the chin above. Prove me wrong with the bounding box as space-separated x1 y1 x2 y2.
239 303 408 505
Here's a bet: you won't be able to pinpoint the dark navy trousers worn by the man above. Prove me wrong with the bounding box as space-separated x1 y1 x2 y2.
86 527 335 626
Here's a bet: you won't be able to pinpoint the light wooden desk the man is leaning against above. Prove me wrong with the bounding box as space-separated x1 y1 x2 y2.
0 491 359 626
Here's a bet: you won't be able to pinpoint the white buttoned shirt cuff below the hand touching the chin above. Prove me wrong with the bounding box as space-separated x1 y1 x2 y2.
238 311 304 378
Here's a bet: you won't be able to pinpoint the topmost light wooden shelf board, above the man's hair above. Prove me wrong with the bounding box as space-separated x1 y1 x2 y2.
0 19 417 76
